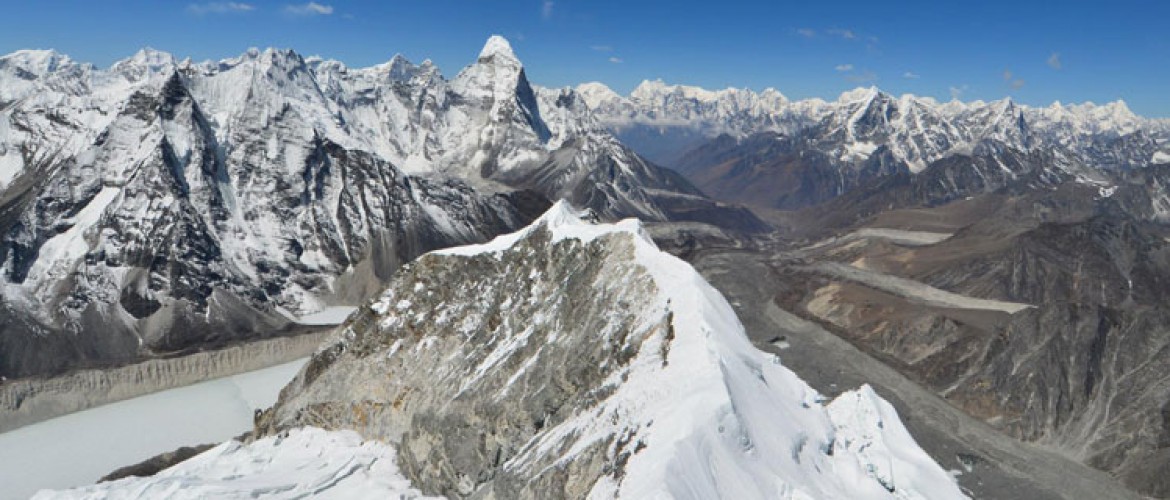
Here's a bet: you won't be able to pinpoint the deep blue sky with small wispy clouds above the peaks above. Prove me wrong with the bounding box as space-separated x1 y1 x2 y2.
0 0 1170 117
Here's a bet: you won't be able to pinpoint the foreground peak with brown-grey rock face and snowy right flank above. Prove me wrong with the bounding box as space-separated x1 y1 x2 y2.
205 201 963 499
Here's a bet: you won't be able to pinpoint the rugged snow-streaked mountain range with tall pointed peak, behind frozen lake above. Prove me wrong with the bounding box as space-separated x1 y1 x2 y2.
0 37 763 377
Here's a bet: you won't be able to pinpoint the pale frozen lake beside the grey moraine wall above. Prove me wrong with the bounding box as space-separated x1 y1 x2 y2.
0 358 307 500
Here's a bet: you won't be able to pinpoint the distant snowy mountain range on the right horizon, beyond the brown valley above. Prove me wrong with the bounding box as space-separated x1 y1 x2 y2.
578 82 1170 171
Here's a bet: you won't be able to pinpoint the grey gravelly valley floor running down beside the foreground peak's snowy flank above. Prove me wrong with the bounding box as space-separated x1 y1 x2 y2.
688 244 1138 499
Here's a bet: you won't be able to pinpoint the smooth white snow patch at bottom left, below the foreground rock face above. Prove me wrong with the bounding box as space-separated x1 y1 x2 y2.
33 427 442 500
